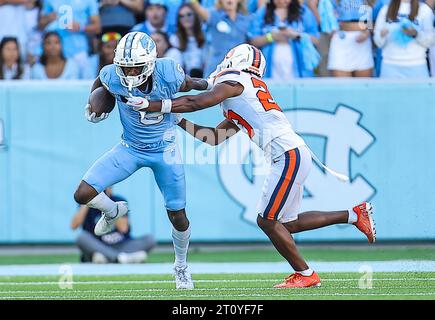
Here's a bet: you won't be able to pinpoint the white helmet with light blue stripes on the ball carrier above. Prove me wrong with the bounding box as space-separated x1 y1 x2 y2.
113 32 157 90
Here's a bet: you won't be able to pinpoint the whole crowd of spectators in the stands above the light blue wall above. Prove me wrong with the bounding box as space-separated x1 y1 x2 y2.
0 0 435 81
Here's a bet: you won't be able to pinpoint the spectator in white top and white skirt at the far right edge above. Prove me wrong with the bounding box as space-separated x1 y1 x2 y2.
374 0 435 78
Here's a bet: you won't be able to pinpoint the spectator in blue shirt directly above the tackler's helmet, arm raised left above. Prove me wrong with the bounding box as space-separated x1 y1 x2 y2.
190 0 251 76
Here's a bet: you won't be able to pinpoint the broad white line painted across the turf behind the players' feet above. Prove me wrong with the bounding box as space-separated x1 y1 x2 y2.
0 260 435 276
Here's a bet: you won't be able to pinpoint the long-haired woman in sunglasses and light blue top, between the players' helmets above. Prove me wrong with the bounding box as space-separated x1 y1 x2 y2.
170 4 205 78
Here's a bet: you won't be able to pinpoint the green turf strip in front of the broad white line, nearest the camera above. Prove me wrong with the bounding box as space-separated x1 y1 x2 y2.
0 272 435 300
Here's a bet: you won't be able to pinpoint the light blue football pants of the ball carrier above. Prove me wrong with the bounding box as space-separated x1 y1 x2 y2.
83 142 186 211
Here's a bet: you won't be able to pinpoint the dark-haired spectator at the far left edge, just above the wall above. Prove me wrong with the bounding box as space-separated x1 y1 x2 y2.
0 37 29 80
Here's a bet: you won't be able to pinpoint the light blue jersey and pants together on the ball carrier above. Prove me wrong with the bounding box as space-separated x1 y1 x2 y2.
83 59 186 211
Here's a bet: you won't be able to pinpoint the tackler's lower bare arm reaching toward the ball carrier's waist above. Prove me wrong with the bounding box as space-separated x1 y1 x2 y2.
178 119 240 146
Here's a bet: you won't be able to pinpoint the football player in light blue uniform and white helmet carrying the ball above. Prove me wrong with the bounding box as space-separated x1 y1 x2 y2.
74 32 211 289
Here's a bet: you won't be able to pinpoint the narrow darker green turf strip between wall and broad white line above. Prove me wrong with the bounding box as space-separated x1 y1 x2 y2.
0 246 435 265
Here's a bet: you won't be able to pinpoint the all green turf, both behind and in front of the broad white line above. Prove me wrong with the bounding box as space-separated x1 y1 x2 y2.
0 246 435 300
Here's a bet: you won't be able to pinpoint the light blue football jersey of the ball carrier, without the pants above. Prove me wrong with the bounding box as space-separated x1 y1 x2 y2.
100 58 185 151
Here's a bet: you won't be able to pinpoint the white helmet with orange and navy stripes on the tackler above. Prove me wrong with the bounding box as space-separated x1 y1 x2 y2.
218 43 266 77
